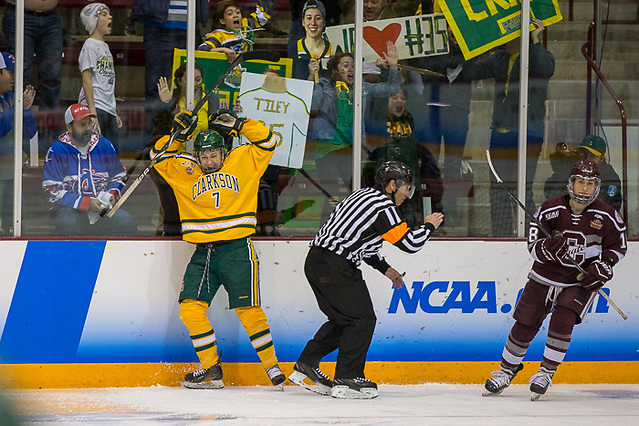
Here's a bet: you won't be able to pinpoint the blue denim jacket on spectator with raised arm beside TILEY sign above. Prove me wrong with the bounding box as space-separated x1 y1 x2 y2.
309 70 402 140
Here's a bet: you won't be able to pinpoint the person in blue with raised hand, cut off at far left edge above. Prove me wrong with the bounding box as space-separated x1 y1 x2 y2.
0 52 38 235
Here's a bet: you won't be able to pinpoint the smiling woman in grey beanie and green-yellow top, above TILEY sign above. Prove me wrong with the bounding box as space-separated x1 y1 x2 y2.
293 0 333 83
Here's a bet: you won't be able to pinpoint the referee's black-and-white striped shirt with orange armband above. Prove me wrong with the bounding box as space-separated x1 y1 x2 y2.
310 188 435 273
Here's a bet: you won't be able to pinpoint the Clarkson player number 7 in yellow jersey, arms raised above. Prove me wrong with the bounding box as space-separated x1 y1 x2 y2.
151 110 286 388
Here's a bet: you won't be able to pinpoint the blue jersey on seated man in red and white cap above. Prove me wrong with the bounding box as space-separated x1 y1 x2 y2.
42 132 126 212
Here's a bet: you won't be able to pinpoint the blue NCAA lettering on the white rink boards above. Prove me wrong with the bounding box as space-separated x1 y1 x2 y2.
388 281 610 314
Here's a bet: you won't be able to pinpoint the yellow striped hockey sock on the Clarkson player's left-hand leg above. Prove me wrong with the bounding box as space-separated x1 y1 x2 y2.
180 299 220 368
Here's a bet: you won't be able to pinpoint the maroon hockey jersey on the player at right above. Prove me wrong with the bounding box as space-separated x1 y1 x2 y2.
528 195 627 287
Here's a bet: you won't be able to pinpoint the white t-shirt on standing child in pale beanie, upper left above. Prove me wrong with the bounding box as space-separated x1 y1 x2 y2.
78 38 116 115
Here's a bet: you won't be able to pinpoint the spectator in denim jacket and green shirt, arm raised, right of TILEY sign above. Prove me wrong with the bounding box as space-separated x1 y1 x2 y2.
309 42 401 223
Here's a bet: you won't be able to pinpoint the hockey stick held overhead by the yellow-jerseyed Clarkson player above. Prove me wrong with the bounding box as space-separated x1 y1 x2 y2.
103 50 280 218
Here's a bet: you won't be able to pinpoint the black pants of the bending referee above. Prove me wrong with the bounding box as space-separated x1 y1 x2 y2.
298 247 377 379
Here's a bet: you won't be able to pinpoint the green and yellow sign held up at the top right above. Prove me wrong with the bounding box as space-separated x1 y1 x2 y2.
438 0 562 59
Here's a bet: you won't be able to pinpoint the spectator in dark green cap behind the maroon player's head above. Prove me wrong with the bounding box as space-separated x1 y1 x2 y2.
577 135 623 211
